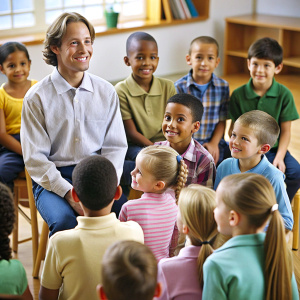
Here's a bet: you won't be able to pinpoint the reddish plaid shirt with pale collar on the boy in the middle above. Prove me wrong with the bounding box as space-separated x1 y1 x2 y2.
155 139 216 188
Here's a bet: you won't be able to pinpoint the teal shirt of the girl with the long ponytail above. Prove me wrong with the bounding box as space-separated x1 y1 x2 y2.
202 233 299 300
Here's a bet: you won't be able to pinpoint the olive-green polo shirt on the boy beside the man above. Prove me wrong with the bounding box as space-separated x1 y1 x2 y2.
115 75 176 143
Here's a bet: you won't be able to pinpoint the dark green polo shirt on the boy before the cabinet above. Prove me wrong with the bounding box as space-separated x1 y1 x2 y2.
229 78 299 148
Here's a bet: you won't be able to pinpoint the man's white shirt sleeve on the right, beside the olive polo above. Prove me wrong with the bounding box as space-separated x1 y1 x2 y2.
101 91 127 181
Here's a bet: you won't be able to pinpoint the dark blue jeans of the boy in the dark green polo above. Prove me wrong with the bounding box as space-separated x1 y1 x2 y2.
266 149 300 201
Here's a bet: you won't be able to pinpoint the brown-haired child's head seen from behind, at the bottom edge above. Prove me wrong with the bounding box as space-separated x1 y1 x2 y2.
97 241 161 300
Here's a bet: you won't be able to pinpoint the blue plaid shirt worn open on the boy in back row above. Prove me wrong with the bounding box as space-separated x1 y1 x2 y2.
175 70 229 143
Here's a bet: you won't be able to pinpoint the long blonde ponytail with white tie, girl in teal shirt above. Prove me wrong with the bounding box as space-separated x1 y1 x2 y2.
221 173 292 300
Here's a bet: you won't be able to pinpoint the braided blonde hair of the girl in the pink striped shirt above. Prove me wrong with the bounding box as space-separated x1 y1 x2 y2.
138 145 188 202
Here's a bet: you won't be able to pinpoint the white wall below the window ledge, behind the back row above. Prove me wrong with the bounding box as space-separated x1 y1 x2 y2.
0 0 253 81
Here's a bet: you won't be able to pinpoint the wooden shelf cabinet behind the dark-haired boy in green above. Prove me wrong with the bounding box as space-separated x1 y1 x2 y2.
224 14 300 75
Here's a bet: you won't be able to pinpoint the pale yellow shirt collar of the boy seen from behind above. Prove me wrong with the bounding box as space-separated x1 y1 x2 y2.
75 213 119 230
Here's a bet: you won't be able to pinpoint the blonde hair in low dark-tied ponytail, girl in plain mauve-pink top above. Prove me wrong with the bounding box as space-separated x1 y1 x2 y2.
178 184 218 287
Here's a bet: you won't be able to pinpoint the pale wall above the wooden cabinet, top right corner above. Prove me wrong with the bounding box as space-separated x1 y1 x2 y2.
256 0 300 17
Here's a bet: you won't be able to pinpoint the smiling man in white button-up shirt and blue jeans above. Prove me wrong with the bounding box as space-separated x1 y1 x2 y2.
21 13 127 236
